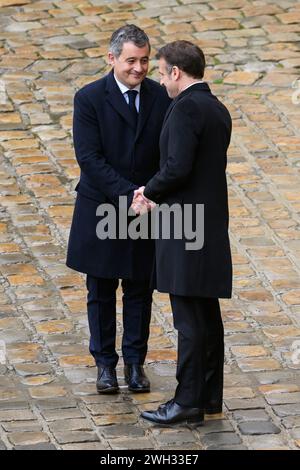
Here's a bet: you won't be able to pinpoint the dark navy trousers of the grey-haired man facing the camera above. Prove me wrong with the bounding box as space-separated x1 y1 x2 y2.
86 275 152 367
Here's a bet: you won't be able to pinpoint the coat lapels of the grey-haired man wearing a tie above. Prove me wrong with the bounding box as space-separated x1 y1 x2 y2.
106 70 156 140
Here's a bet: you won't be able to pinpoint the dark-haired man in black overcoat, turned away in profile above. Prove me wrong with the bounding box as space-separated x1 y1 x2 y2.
139 41 232 424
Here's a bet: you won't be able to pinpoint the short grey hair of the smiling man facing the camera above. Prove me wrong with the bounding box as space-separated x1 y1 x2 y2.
109 24 150 57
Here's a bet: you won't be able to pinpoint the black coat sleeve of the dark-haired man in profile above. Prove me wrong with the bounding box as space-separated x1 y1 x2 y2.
144 100 201 202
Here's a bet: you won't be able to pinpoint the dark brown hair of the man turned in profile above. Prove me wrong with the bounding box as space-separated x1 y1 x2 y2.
156 40 205 78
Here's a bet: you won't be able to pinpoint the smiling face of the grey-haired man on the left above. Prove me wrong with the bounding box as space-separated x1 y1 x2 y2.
108 42 150 88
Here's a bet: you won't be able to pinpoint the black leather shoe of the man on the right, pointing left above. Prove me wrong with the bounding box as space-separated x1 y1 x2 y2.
141 399 204 426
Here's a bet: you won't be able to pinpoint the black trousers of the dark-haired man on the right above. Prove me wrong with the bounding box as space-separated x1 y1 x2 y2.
170 294 224 412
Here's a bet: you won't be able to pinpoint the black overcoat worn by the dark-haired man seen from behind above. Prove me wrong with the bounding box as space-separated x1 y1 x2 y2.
144 83 232 298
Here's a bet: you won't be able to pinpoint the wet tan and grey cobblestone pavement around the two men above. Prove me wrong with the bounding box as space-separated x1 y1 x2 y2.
0 0 300 449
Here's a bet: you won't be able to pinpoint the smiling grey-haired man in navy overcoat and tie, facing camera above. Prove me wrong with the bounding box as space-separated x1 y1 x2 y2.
67 25 170 393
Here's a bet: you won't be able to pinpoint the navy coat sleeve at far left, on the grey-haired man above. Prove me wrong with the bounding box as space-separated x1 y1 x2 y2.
73 91 138 207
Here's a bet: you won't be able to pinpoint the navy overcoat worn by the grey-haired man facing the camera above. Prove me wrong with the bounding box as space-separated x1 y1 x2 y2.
66 71 170 280
